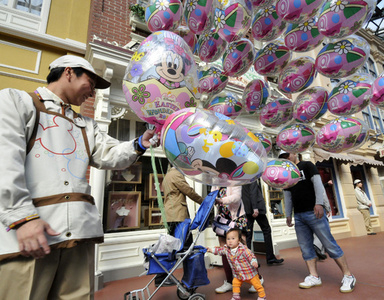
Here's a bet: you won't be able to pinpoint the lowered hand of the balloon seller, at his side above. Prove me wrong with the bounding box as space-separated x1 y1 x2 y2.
16 219 60 258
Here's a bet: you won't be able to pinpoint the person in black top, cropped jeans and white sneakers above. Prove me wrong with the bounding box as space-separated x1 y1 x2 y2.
279 151 356 293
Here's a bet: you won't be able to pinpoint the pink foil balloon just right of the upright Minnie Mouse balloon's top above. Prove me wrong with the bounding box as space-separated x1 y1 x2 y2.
196 29 228 63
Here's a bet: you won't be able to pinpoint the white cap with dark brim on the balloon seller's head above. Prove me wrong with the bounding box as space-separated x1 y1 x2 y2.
49 55 111 89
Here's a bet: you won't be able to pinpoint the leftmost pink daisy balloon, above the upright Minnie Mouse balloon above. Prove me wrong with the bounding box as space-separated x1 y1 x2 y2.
145 0 183 32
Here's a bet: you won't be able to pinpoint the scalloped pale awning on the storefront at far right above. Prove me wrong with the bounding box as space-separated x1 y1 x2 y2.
313 148 384 167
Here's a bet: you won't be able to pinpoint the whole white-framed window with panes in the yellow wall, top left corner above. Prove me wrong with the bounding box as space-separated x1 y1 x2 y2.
0 0 51 33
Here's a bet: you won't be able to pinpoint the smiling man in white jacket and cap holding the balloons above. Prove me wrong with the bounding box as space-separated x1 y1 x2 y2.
0 55 158 300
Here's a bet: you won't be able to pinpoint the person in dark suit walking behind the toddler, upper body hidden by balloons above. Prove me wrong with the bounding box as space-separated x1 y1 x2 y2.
241 181 284 266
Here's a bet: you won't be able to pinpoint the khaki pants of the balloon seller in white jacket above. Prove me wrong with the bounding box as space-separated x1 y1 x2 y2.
0 243 95 300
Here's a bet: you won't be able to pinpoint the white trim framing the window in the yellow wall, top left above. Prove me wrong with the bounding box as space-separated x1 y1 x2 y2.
0 0 51 33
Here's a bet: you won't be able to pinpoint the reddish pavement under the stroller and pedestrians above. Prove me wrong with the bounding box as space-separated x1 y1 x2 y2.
95 232 384 300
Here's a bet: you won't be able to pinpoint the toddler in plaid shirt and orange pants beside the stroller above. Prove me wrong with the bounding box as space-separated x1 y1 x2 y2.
207 228 267 300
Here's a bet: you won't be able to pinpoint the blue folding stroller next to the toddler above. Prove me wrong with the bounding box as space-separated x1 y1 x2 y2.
124 191 219 300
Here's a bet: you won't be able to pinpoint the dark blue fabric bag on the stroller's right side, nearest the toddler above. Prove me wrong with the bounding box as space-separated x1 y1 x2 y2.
181 246 209 289
